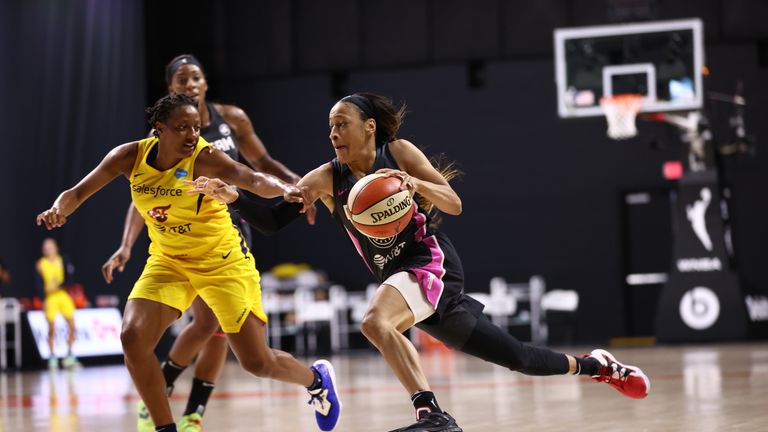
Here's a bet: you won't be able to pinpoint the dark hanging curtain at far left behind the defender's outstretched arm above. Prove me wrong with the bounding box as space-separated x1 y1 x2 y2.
0 0 146 304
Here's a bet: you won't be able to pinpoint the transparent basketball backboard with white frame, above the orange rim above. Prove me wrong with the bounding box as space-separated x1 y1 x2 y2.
554 19 704 118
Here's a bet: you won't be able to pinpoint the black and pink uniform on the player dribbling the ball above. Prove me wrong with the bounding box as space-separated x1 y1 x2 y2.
331 144 464 312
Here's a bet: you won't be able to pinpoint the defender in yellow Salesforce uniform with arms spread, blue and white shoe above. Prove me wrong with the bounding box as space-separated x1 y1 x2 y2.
37 94 340 431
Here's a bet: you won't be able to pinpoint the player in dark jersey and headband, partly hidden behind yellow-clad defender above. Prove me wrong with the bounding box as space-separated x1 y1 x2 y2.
102 54 315 432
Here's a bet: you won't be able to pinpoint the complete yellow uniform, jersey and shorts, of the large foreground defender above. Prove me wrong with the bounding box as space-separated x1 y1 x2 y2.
129 137 267 333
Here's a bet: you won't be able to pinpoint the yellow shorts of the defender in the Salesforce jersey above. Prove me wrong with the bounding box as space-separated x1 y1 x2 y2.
128 238 267 333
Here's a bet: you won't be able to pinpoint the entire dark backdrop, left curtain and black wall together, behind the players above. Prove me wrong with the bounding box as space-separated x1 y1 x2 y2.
0 0 768 341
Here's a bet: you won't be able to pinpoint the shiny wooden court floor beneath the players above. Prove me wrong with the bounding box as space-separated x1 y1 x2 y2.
0 343 768 432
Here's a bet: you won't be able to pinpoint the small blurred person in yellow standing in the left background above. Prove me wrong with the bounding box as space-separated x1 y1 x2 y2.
36 238 78 368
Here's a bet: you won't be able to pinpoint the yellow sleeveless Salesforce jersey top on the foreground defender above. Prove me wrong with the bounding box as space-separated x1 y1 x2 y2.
130 137 245 259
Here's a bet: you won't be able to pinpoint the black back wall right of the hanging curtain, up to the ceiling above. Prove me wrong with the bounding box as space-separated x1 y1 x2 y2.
136 0 768 341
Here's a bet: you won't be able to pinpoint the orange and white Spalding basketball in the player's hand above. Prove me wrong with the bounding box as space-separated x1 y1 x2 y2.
347 174 413 239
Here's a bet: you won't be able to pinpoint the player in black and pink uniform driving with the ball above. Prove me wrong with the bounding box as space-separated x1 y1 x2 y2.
194 93 650 432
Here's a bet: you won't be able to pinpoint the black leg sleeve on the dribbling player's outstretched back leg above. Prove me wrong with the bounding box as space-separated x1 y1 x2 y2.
460 315 569 375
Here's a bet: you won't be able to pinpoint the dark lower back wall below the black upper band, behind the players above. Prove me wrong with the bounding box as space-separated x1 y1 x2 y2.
214 54 768 342
